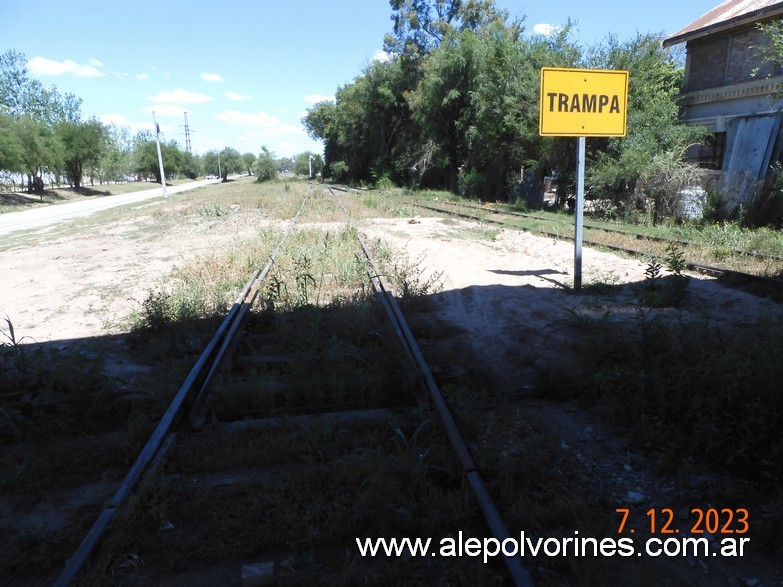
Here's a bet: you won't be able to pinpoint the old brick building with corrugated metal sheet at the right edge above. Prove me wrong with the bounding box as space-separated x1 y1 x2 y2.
663 0 783 208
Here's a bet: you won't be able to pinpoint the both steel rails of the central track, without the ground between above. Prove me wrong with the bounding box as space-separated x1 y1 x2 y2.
55 186 532 586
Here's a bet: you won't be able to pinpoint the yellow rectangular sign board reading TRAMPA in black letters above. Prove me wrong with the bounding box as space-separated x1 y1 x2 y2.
539 67 628 137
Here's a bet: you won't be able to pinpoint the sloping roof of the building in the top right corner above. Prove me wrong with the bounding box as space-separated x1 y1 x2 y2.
663 0 783 47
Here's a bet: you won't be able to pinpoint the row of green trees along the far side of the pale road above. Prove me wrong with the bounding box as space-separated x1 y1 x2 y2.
0 50 323 194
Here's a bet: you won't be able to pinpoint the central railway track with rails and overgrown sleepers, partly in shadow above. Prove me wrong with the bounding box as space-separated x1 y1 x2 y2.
56 188 532 585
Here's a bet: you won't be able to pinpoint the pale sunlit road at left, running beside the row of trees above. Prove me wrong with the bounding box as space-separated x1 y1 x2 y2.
0 180 216 237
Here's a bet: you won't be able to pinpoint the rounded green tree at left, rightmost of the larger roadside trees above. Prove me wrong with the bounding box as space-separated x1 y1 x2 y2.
55 118 109 190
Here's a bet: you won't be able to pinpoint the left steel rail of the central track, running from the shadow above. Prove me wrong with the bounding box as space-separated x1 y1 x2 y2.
54 190 311 587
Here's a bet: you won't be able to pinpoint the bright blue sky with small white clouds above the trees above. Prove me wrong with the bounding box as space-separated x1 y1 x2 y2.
0 0 720 156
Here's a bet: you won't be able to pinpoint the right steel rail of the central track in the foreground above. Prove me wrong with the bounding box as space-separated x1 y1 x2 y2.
329 187 533 587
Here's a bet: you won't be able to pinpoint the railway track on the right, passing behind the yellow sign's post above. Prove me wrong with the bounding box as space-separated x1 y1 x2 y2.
411 203 783 300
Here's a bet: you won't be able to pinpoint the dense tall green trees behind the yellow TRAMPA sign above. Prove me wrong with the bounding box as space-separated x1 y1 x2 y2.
302 0 702 211
